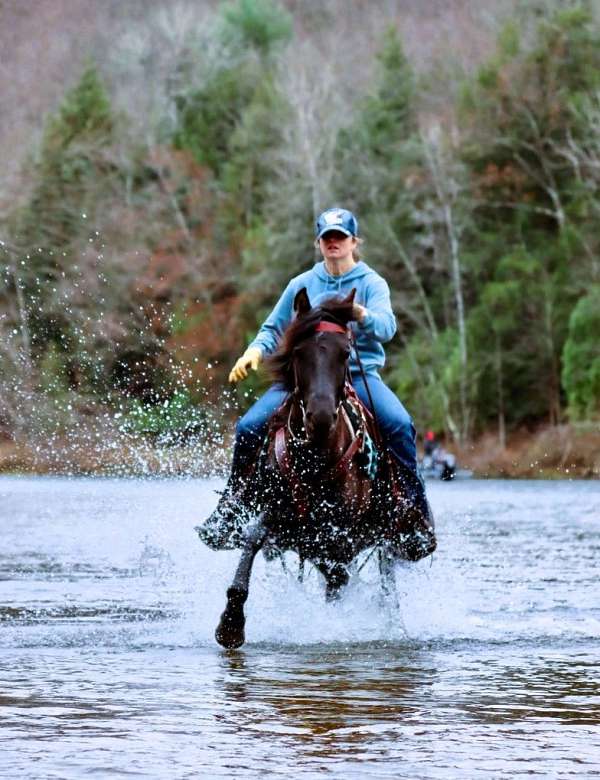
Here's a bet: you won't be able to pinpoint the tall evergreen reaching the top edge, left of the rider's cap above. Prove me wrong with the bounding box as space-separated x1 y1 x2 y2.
173 0 291 402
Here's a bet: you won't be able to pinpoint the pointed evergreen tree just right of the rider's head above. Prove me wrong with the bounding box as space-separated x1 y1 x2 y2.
338 29 470 438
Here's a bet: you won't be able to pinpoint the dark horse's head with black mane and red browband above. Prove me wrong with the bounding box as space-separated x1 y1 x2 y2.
270 288 356 446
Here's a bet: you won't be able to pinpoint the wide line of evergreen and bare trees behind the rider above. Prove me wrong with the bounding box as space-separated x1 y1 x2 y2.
0 0 600 444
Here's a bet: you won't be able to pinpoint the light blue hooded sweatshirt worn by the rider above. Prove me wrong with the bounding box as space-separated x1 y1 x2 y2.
250 261 396 373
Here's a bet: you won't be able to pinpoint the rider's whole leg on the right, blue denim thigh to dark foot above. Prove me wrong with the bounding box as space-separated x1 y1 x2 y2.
352 374 435 559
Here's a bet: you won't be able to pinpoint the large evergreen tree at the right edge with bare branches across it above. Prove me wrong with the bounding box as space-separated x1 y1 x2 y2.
454 5 600 424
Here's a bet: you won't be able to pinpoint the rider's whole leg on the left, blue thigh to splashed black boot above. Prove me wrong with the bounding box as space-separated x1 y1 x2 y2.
196 384 287 550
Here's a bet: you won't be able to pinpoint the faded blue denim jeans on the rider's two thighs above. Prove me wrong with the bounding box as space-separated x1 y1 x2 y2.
234 374 420 482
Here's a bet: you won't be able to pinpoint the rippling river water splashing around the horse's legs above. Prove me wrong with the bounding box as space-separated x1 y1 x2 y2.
0 477 600 779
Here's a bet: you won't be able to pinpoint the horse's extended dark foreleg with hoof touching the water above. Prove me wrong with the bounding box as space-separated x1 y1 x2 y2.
215 515 266 648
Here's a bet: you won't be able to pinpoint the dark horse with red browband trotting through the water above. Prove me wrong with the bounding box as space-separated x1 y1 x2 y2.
209 289 436 648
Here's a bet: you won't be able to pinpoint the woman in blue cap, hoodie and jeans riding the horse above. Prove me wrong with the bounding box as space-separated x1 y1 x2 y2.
198 208 431 550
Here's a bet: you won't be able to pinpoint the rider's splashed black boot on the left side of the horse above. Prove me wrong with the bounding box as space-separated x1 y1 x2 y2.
195 442 257 550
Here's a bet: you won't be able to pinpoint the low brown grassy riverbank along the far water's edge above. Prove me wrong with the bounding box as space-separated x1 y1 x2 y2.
0 425 600 479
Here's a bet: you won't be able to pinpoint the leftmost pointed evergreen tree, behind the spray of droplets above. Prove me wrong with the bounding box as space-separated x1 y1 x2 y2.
5 65 115 370
